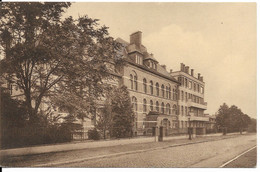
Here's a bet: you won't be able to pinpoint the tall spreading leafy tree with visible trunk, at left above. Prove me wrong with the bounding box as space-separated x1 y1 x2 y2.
0 2 122 123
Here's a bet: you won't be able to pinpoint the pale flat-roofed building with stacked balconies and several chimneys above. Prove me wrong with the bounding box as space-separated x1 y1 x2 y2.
170 63 209 134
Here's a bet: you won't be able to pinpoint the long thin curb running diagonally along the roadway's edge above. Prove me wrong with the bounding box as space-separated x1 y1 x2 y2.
31 136 240 167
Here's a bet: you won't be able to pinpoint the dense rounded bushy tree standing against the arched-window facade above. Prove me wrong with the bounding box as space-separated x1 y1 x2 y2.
96 86 134 139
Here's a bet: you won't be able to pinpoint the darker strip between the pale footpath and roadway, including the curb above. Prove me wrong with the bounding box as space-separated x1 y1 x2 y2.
1 134 250 167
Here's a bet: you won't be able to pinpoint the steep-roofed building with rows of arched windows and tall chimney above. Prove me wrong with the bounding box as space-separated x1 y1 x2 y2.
117 31 179 135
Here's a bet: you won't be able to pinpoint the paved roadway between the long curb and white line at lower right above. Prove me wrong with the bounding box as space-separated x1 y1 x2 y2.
59 135 256 167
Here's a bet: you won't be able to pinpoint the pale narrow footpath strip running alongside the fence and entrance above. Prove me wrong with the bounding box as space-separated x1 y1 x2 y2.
0 133 240 157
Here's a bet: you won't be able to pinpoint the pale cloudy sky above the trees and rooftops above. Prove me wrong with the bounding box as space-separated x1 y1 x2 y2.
63 2 256 118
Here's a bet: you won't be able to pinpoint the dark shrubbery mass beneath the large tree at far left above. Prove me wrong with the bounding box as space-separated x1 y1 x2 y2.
0 87 72 148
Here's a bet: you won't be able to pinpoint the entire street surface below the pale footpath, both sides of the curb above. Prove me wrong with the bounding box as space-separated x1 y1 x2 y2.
2 134 256 167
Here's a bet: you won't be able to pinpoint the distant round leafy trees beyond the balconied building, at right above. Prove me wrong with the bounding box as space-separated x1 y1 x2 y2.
216 103 251 133
